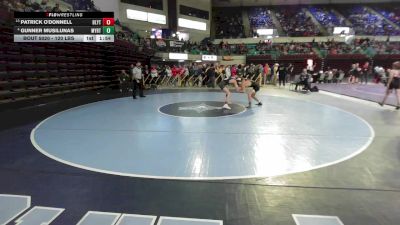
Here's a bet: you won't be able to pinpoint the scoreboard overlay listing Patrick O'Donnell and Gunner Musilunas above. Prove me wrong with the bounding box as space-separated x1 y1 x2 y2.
14 12 115 42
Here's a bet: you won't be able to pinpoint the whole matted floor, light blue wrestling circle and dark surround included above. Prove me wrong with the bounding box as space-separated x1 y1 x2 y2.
0 87 400 225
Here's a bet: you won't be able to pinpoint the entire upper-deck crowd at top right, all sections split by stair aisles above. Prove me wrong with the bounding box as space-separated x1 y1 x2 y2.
216 4 400 38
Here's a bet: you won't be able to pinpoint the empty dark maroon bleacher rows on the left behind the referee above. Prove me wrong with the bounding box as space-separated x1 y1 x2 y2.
0 2 154 104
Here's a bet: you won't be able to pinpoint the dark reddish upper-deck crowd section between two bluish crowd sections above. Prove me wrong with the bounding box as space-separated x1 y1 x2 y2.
276 7 322 37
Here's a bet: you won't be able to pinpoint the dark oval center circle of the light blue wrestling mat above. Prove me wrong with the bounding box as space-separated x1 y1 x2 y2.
159 101 246 117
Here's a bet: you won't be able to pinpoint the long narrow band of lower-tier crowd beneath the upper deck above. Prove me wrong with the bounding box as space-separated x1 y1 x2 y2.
151 35 400 57
